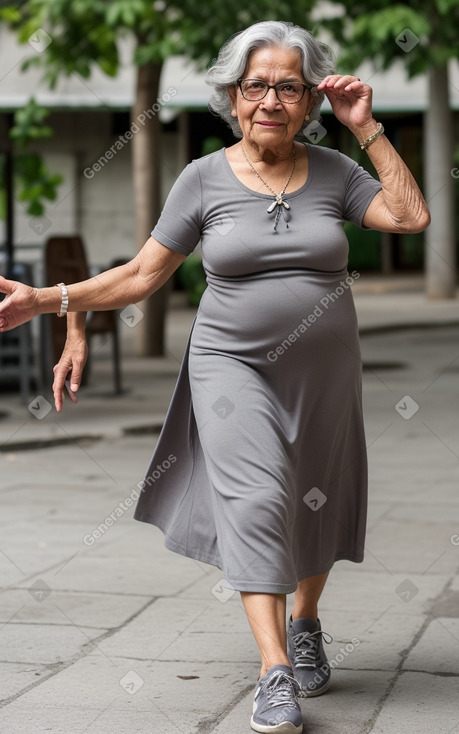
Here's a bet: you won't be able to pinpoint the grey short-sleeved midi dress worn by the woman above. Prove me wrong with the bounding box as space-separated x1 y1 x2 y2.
135 145 381 593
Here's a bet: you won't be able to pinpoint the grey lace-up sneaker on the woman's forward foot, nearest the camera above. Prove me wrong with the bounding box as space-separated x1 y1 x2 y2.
250 665 303 734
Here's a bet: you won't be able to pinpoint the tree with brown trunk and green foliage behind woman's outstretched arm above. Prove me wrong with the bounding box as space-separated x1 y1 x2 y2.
0 0 324 355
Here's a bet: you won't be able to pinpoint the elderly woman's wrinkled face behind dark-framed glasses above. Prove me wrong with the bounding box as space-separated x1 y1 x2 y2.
228 46 316 148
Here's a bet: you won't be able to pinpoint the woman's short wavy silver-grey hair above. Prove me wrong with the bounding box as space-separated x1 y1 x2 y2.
206 20 335 138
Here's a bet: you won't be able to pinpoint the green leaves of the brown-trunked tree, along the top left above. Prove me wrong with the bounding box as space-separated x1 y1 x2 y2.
0 0 315 80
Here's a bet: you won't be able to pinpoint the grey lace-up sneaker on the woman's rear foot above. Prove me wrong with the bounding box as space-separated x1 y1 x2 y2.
287 617 333 698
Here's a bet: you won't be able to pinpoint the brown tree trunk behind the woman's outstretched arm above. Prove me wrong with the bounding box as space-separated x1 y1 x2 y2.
131 63 169 357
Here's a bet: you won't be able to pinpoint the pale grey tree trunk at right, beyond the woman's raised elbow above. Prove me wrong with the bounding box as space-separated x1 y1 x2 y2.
424 64 456 298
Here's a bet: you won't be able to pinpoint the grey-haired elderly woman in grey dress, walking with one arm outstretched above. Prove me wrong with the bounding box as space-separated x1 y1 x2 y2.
0 22 429 734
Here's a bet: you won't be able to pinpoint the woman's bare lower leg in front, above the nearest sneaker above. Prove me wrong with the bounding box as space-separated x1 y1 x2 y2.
241 591 290 678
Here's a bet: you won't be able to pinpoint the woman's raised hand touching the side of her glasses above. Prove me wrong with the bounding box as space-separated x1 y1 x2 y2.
317 74 373 132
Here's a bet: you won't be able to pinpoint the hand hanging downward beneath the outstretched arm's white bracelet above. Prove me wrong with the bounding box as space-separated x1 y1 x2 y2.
53 329 88 413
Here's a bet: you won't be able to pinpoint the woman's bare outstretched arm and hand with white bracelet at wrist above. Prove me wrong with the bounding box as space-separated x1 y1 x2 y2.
0 237 185 332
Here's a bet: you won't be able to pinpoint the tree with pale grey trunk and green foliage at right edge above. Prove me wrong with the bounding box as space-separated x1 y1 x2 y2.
323 0 459 298
